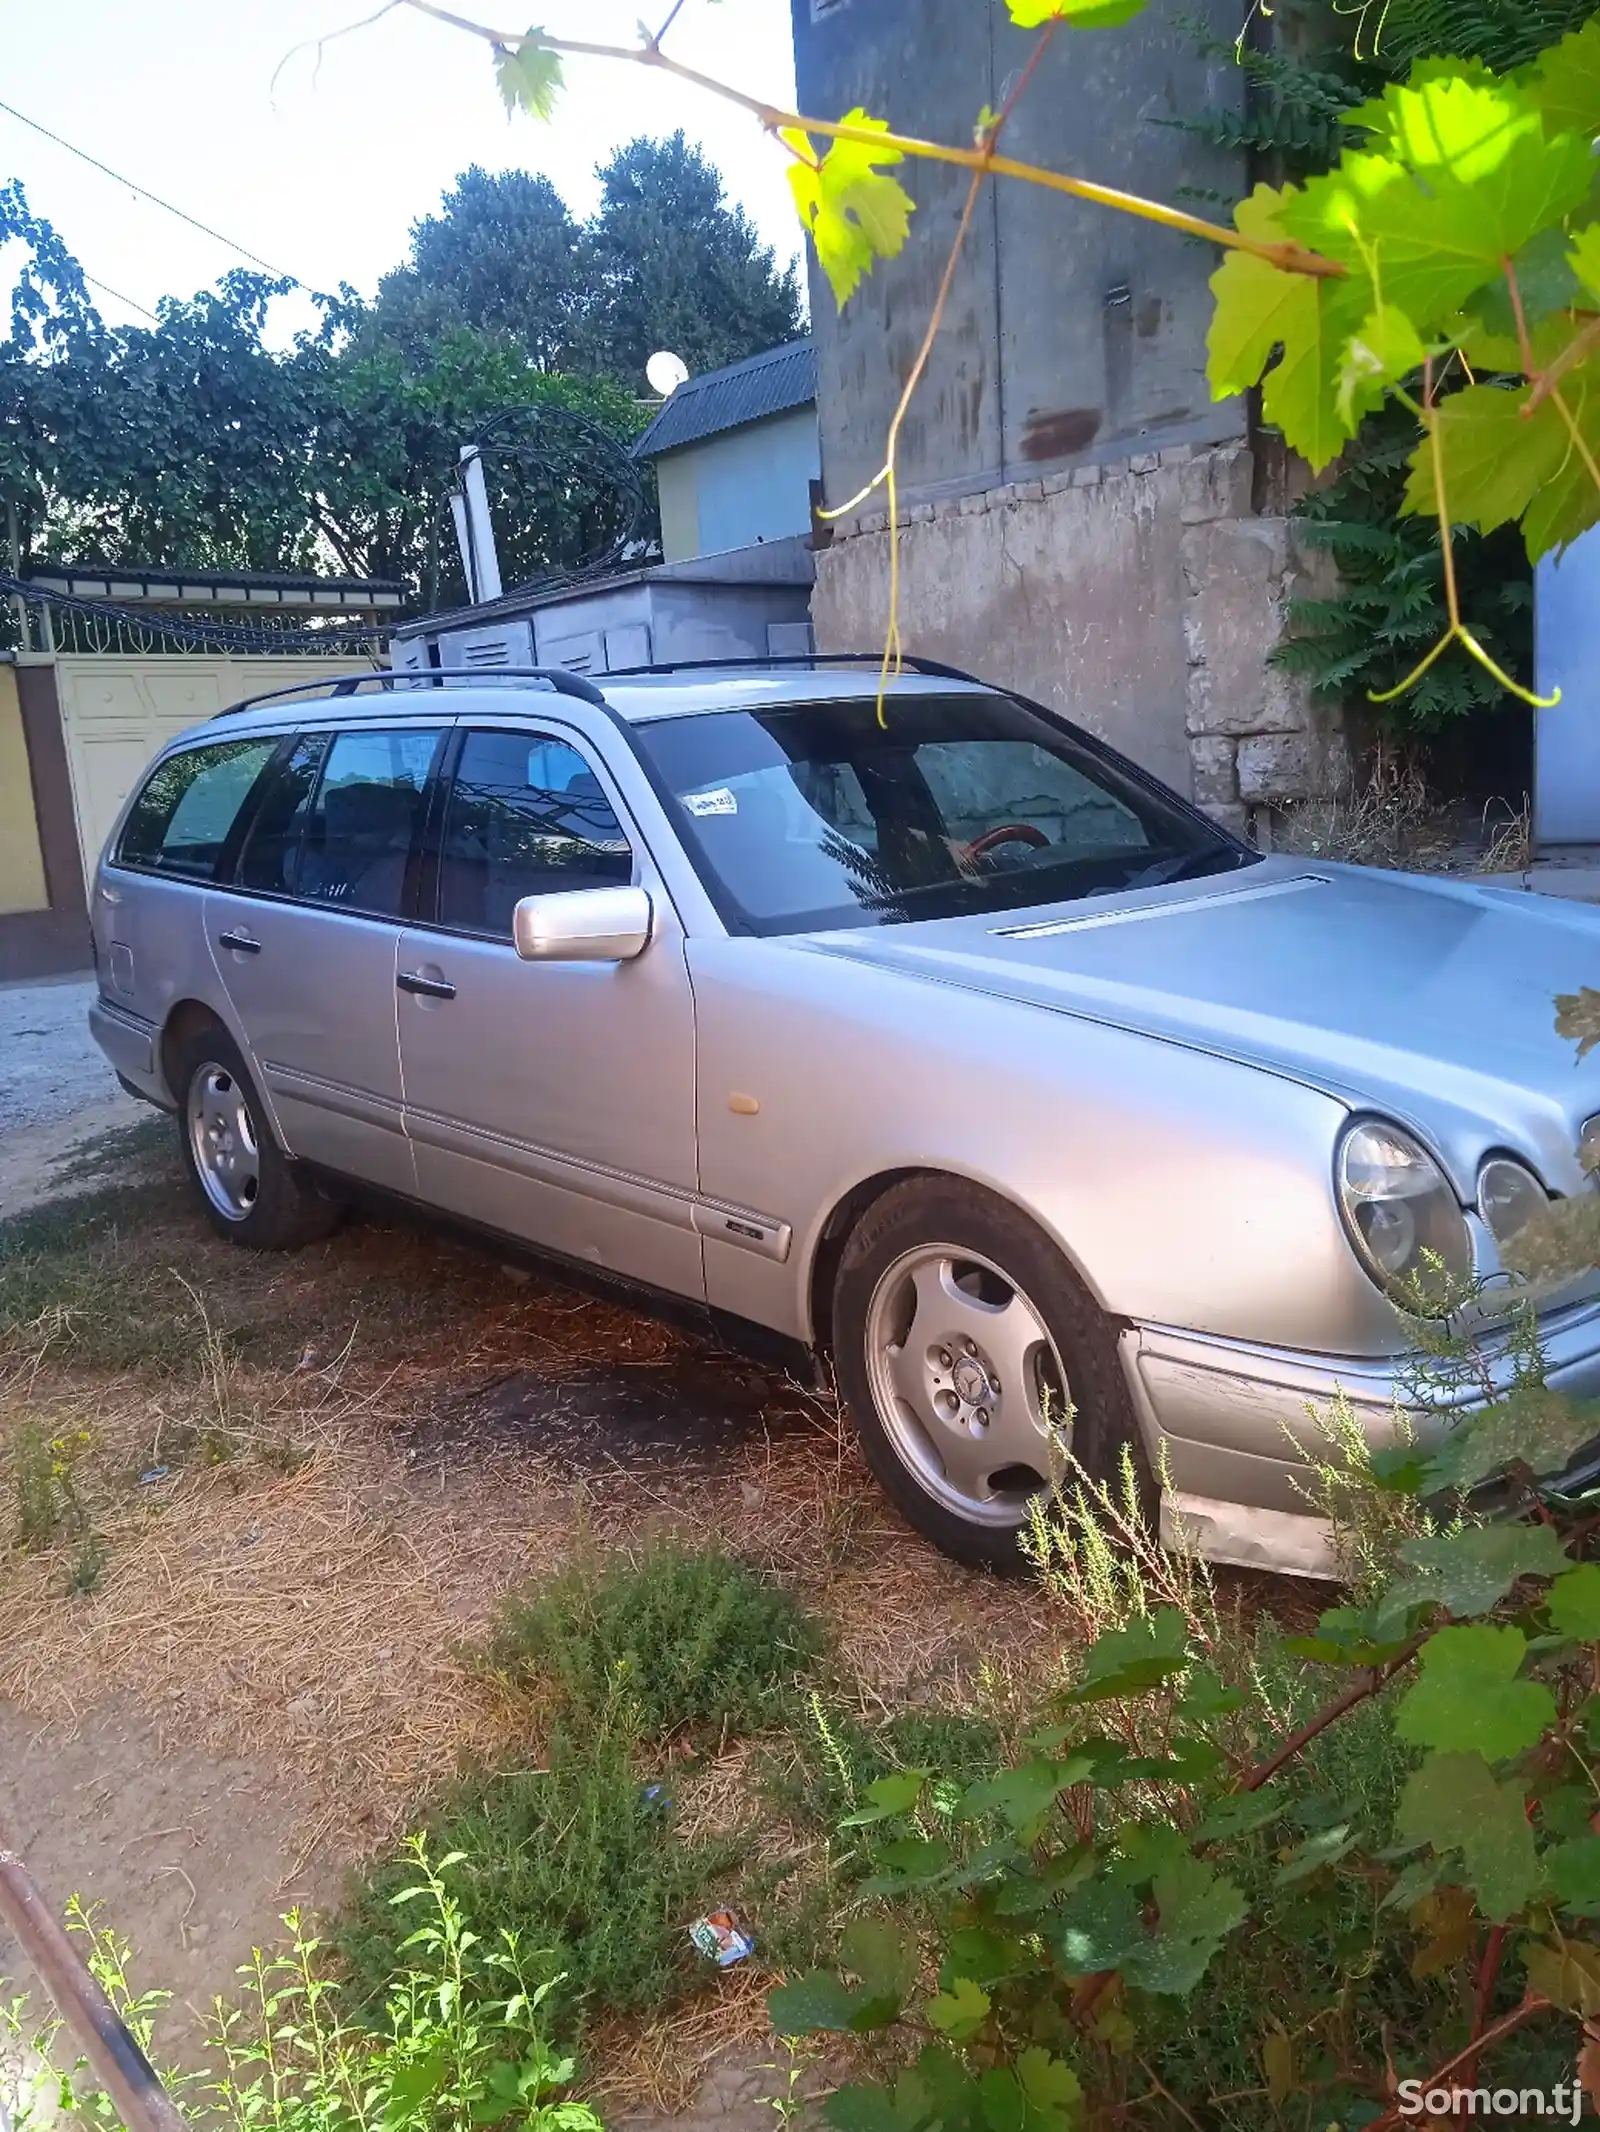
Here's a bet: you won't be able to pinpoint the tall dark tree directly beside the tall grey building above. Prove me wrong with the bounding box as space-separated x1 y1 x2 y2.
582 132 802 392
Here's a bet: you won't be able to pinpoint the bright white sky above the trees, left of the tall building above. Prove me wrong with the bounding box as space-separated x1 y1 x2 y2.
0 0 798 339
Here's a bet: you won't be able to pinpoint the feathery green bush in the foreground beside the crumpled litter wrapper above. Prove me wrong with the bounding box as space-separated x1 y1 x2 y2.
339 1714 740 2036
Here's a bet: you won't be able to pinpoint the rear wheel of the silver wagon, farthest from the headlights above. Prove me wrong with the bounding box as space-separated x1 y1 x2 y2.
173 1023 343 1251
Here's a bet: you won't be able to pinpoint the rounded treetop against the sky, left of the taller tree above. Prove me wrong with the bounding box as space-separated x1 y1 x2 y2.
373 164 585 371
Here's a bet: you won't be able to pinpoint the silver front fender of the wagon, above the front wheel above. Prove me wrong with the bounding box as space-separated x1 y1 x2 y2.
689 938 1404 1354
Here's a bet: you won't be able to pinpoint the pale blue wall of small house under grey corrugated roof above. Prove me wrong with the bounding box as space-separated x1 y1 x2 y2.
655 407 821 563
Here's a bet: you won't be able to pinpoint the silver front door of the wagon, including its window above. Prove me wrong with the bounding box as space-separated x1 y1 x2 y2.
397 721 704 1298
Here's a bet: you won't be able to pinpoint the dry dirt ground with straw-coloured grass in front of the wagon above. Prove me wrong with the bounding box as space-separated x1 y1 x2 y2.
0 1113 1079 2132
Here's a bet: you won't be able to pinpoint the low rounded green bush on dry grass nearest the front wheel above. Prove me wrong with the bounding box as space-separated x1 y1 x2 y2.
489 1541 821 1740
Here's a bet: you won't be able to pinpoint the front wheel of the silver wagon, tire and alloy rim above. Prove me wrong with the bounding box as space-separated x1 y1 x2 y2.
832 1177 1158 1573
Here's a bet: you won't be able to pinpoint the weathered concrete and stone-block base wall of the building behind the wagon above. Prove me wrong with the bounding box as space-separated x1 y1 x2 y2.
813 443 1346 829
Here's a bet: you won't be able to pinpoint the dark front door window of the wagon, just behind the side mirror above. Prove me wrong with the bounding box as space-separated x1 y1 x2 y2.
439 733 634 940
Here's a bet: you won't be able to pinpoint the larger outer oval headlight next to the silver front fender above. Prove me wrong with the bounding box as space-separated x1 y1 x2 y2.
1335 1117 1472 1303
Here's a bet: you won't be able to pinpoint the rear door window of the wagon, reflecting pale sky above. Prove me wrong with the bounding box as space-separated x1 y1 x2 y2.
286 731 439 917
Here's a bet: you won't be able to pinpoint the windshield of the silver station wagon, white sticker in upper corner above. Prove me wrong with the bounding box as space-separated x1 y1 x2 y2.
634 693 1254 934
